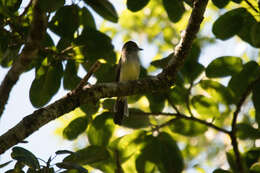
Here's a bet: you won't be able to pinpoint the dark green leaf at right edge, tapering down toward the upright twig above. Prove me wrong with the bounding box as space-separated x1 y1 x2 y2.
228 61 260 101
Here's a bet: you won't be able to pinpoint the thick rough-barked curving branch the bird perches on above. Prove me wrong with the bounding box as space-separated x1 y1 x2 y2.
0 0 208 153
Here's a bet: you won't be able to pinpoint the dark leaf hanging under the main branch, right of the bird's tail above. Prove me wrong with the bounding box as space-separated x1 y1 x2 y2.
146 93 166 113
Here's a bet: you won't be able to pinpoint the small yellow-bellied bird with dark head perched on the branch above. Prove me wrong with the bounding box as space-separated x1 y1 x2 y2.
114 41 143 125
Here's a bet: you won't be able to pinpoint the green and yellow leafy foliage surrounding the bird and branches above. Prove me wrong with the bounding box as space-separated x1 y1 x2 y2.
0 0 260 173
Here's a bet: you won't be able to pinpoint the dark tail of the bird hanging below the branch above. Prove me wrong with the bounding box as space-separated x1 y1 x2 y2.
114 97 129 125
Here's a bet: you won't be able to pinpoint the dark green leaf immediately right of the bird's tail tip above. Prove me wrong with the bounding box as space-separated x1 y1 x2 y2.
122 108 150 129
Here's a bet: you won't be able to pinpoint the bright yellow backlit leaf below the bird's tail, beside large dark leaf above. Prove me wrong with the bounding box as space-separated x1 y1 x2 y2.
109 130 146 162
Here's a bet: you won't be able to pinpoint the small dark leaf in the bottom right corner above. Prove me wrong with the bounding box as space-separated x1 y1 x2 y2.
244 147 260 168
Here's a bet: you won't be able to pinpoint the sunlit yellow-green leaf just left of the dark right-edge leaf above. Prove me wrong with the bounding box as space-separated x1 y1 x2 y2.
200 80 234 104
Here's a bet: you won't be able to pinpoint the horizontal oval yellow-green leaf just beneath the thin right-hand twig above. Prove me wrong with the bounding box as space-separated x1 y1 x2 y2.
169 119 208 136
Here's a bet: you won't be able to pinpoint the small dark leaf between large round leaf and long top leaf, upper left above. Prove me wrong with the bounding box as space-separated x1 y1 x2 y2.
79 7 96 29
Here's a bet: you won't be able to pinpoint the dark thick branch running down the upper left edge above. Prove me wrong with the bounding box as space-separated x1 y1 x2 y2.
0 0 47 115
